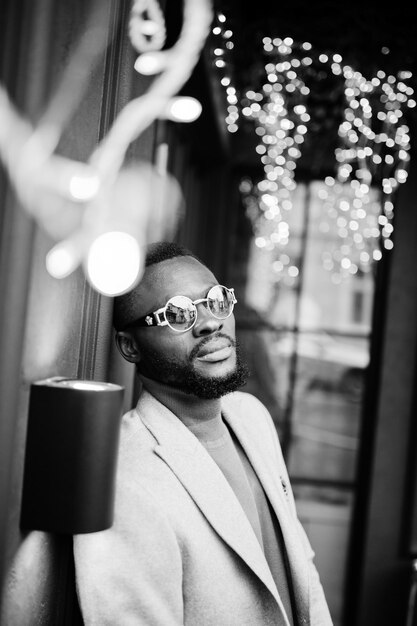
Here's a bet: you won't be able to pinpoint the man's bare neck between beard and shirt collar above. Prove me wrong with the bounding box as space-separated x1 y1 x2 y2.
139 375 221 430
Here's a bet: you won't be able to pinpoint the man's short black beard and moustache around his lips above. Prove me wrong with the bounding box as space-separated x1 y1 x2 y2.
137 333 249 400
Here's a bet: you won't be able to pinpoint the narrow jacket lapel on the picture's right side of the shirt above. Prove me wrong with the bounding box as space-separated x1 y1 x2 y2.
223 405 310 625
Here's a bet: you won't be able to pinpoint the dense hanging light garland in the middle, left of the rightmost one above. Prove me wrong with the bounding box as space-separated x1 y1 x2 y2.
237 37 312 285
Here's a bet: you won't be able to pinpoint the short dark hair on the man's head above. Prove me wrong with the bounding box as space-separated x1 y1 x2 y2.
113 241 202 331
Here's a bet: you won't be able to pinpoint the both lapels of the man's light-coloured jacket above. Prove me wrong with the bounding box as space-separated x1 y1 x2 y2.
136 390 308 624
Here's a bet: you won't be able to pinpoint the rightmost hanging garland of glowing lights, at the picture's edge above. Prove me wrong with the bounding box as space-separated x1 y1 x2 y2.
321 62 416 277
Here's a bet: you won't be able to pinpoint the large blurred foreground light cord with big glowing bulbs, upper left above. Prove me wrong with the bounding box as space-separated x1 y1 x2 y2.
0 0 211 295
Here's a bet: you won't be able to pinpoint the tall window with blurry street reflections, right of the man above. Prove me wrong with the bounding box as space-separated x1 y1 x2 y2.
237 181 376 625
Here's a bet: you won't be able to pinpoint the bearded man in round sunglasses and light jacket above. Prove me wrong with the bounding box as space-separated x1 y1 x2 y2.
74 243 332 626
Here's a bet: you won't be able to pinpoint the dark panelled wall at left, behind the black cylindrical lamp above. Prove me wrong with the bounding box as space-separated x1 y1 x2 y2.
0 0 155 626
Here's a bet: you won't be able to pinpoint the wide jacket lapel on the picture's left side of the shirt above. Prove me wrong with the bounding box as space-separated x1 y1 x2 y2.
136 391 287 623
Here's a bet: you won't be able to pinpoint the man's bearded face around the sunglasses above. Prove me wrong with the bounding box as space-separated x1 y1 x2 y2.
123 256 246 398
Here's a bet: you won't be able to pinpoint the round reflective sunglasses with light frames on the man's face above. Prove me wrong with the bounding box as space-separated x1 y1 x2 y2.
129 285 237 333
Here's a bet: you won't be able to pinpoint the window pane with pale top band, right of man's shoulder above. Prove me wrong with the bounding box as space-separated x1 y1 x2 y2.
288 331 366 482
